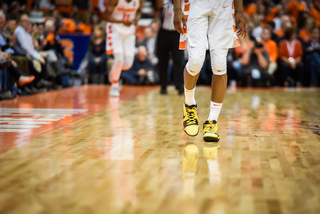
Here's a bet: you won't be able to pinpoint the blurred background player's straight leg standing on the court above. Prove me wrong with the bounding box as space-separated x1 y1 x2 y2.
109 35 124 96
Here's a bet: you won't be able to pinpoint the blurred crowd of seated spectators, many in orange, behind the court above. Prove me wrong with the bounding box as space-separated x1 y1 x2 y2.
0 0 320 100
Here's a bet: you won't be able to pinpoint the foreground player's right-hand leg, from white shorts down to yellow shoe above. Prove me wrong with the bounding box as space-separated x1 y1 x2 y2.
203 1 237 142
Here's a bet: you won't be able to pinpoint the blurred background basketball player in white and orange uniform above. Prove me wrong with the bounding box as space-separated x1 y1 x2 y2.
105 0 143 96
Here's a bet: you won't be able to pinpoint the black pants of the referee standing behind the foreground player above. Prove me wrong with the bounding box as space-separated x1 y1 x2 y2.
157 29 184 89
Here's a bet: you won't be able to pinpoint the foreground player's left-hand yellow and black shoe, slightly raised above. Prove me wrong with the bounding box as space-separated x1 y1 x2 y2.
183 104 199 137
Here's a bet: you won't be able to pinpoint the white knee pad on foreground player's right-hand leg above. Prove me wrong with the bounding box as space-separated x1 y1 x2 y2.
210 49 228 75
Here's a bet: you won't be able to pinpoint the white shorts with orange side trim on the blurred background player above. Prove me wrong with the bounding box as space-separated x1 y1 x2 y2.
106 23 136 57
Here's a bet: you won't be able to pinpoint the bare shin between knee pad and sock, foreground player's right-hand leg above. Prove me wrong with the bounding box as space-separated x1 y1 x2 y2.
211 74 228 103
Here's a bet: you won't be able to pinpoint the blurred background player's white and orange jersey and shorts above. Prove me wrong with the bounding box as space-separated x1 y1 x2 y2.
106 0 140 70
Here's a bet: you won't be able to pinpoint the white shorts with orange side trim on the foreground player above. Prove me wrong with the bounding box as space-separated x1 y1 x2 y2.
180 0 240 51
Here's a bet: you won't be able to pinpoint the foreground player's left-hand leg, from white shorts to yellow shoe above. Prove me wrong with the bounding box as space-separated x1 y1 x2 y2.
183 6 208 136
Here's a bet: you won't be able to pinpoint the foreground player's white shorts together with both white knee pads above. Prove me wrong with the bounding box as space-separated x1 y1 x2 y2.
180 0 240 75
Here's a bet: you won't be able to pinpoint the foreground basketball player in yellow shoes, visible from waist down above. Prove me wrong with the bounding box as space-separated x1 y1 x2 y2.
174 0 247 142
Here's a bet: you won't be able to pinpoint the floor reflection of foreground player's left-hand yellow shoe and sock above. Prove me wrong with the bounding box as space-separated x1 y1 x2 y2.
182 143 199 198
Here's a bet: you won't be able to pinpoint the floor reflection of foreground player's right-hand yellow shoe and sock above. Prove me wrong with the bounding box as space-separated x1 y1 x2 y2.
203 142 221 186
